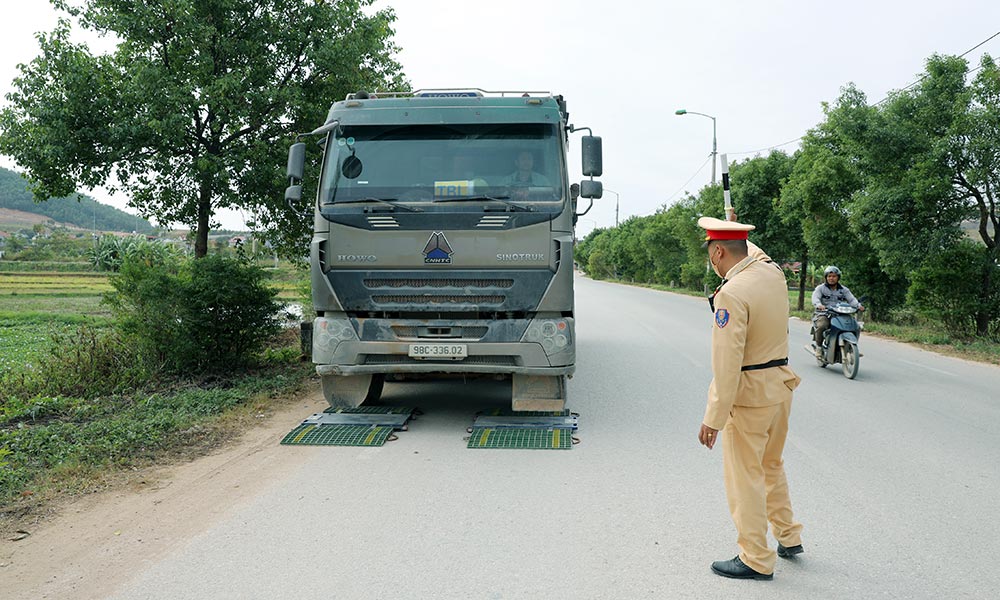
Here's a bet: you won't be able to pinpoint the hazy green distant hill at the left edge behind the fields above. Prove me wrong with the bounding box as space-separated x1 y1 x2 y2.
0 167 153 233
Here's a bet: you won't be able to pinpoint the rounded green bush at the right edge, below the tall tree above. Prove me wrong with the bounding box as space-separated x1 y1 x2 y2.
908 241 1000 337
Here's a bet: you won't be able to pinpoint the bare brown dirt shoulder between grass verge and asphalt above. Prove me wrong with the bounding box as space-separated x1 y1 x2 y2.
0 391 326 600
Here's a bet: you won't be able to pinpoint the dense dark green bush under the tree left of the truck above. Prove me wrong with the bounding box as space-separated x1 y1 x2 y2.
107 255 280 373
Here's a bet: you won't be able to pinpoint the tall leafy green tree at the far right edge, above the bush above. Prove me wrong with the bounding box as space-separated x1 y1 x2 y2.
843 55 1000 336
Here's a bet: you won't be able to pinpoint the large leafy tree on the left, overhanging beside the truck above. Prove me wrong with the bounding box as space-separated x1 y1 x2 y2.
0 0 405 257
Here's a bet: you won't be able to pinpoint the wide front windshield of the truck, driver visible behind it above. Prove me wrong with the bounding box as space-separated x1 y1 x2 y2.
320 123 564 204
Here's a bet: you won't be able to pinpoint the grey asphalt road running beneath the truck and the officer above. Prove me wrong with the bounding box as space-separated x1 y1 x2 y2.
105 278 1000 600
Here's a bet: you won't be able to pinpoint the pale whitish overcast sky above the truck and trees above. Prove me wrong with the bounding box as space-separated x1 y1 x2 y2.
0 0 1000 237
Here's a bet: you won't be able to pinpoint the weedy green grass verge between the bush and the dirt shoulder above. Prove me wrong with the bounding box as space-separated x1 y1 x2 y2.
0 363 312 506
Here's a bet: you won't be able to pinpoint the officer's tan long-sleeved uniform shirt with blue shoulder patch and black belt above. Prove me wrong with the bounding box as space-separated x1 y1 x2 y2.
703 255 800 430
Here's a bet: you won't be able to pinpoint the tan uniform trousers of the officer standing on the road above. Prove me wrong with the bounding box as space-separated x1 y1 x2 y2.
722 394 802 573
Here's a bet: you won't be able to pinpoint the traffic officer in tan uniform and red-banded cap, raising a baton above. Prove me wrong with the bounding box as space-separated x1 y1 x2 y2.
698 217 802 579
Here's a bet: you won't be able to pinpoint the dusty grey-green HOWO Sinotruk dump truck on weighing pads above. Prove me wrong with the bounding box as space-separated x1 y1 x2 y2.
285 89 603 411
